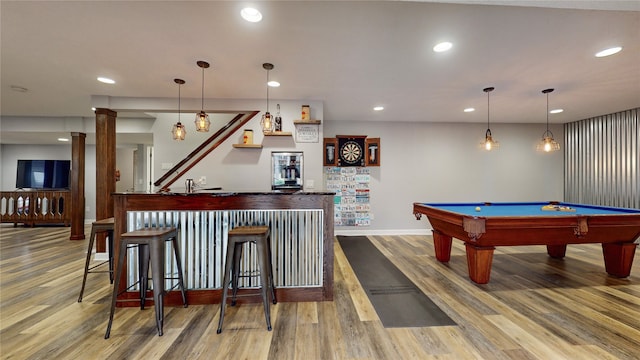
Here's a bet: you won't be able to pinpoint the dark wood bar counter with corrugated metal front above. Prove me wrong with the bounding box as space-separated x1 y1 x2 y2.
113 191 334 306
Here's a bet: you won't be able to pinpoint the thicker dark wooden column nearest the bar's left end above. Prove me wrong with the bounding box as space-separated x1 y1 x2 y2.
96 108 118 252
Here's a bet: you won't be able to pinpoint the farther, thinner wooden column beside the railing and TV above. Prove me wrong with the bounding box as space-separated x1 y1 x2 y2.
69 132 87 240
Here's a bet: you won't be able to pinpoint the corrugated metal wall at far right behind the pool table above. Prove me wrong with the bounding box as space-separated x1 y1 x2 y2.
564 108 640 209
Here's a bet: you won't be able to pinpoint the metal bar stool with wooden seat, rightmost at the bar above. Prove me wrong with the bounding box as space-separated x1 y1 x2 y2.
217 226 277 334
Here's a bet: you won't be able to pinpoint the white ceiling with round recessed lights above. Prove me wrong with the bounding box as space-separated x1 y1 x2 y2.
0 0 640 143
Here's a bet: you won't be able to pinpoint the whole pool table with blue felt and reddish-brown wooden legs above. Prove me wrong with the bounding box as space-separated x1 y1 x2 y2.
413 202 640 284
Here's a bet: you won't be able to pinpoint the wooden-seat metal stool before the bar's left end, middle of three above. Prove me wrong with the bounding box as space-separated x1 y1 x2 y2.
104 227 187 339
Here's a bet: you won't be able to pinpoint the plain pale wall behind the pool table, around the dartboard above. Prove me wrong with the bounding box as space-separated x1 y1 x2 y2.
324 121 564 234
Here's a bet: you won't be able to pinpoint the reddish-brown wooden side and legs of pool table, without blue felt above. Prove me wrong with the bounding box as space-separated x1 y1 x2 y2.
413 203 640 284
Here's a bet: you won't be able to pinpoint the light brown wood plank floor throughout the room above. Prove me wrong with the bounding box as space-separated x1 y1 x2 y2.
0 225 640 360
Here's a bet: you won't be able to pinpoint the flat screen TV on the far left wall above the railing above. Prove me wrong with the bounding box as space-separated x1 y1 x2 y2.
16 160 71 189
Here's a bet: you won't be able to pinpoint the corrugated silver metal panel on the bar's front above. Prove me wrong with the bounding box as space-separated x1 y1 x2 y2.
127 209 324 289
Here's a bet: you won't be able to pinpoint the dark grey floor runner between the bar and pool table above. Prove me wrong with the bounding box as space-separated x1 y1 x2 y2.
338 236 456 327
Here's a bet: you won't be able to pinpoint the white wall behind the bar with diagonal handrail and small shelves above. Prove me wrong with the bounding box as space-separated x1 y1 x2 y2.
152 100 323 191
